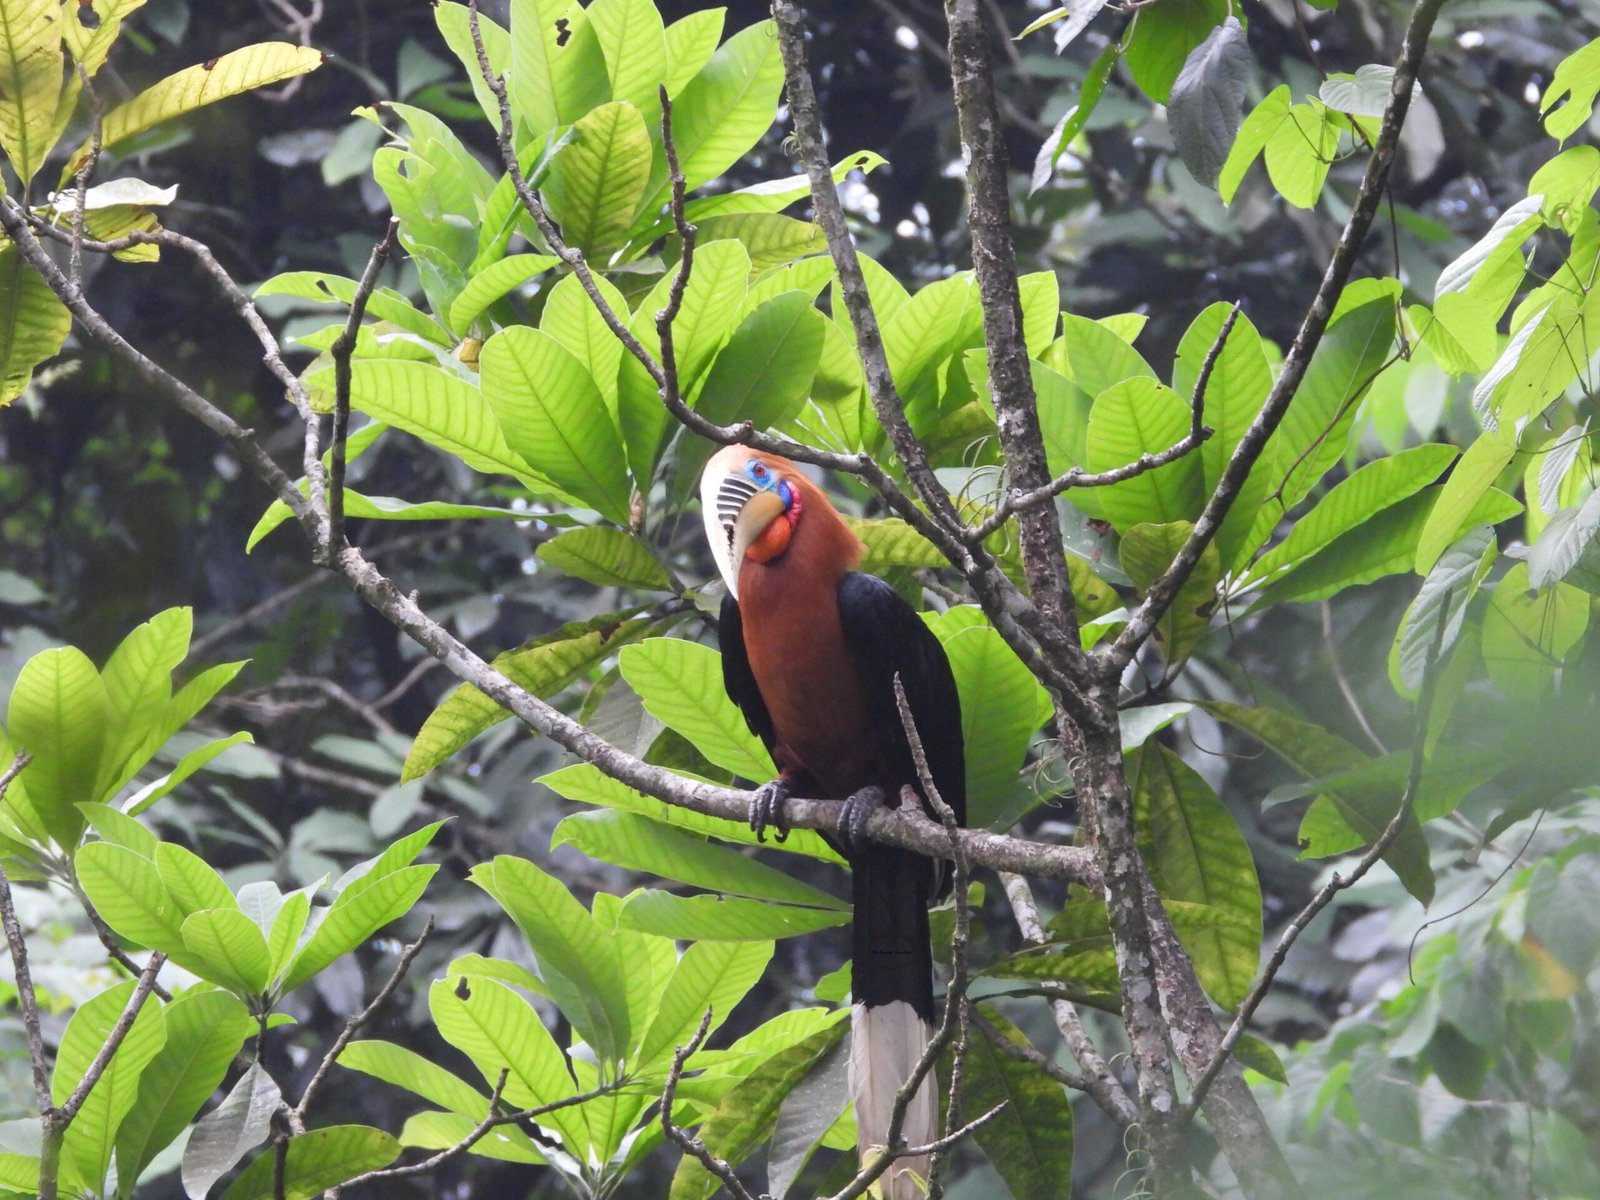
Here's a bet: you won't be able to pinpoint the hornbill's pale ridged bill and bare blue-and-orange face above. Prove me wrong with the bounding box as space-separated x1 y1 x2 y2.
701 446 808 600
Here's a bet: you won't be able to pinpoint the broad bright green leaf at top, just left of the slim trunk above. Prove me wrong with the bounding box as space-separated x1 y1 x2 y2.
638 21 784 214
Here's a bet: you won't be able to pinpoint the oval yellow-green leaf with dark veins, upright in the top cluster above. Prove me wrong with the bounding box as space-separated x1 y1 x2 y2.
546 100 661 262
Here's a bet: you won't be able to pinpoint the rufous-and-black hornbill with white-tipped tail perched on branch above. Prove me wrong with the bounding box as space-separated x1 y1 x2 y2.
701 446 966 1200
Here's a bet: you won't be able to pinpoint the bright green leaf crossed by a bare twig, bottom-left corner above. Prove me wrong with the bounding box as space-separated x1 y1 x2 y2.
50 979 166 1192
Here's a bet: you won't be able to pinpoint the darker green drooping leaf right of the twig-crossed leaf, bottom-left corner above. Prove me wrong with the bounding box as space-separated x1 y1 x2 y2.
117 990 256 1197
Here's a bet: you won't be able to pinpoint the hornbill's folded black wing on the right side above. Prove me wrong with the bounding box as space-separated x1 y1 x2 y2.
838 571 966 826
